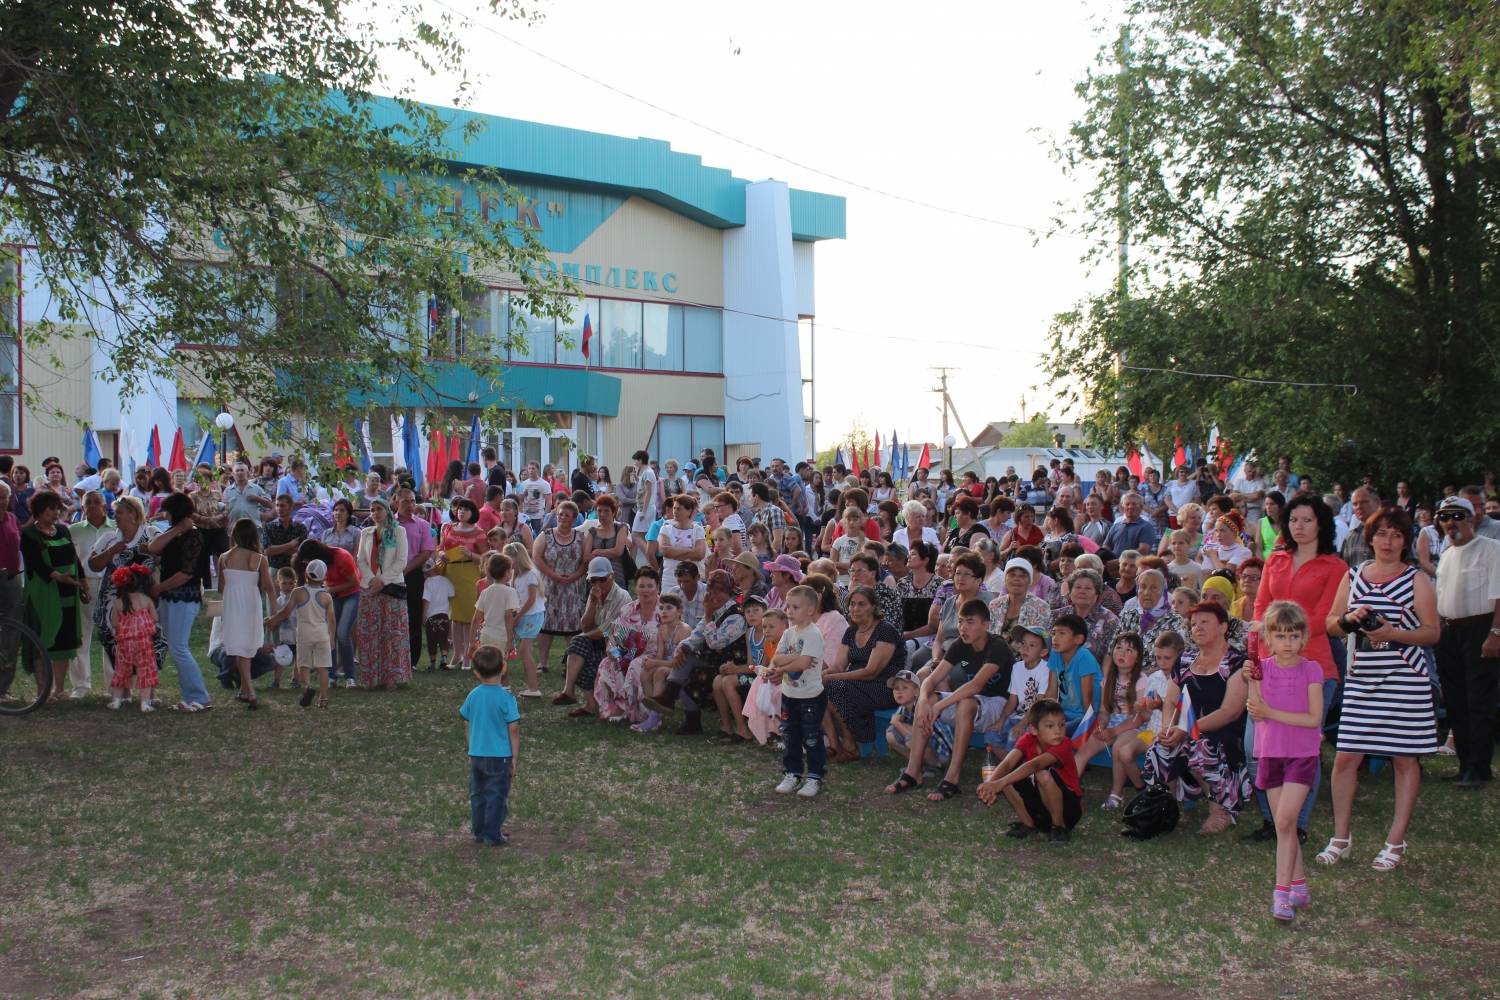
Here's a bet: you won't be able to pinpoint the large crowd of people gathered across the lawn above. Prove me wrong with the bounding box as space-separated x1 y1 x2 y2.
0 450 1500 919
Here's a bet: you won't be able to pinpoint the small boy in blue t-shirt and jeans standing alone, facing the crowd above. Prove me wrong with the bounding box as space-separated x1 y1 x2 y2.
459 646 521 847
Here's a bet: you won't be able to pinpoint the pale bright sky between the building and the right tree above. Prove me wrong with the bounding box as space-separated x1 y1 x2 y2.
390 0 1118 448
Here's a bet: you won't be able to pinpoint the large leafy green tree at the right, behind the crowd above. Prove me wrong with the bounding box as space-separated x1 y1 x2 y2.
1049 0 1500 486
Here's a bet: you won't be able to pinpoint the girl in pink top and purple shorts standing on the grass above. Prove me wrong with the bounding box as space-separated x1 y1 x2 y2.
1245 601 1323 921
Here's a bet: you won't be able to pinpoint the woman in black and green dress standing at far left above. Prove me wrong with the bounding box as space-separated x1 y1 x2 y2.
21 490 89 702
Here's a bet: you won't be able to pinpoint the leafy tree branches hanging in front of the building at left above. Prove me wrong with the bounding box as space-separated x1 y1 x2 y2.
0 0 572 452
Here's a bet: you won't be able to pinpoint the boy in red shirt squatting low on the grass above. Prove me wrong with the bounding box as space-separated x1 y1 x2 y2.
980 699 1083 844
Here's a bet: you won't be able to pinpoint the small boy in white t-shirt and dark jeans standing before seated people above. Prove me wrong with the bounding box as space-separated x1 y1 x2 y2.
767 586 828 799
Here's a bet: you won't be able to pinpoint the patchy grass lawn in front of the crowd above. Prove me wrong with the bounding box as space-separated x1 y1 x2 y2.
0 620 1500 999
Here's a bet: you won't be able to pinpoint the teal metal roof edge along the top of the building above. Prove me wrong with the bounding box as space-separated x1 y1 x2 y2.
372 97 845 241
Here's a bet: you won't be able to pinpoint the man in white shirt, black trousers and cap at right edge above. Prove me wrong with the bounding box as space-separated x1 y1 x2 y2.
1437 496 1500 789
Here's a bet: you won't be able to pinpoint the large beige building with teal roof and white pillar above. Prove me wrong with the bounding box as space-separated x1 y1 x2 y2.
0 95 845 474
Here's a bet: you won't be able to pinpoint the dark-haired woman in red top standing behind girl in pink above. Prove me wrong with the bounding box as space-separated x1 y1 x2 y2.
1245 496 1349 840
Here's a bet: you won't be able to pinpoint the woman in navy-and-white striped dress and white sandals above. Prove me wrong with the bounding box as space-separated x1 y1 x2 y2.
1317 507 1439 871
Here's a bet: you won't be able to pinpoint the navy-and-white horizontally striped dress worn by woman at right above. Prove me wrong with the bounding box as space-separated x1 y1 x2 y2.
1338 562 1437 757
